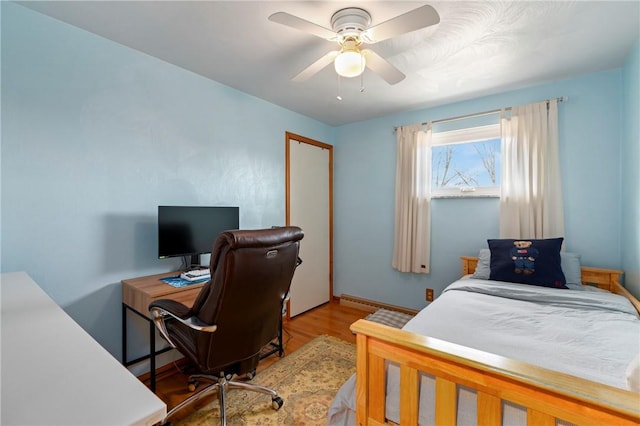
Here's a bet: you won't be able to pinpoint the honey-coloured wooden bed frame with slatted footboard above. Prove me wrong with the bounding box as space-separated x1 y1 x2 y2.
351 256 640 426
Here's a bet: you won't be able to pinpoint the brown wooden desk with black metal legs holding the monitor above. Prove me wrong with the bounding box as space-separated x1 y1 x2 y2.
121 271 204 392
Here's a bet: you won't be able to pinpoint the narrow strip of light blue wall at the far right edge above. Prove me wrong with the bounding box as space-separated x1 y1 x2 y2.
621 41 640 296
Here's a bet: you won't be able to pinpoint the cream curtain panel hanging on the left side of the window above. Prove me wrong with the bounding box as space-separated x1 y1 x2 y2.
392 124 431 274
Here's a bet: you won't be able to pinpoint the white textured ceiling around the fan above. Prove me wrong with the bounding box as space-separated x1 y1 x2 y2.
21 0 640 125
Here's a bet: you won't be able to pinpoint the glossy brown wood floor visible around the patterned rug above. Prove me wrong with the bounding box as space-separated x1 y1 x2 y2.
143 301 369 422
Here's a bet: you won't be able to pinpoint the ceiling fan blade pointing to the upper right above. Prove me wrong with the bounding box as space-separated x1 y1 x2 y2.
363 4 440 44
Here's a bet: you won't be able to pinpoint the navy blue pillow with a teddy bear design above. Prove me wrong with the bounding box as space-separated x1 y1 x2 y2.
487 238 567 288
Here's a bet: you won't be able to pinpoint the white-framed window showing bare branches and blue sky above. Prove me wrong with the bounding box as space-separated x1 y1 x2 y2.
431 124 501 198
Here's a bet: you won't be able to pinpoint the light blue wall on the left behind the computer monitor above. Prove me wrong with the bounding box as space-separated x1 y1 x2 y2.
1 2 334 358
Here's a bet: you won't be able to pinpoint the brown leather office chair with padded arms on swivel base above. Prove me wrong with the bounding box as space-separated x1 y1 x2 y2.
149 226 304 425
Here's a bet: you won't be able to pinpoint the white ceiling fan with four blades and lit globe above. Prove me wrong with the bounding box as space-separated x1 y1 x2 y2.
269 5 440 84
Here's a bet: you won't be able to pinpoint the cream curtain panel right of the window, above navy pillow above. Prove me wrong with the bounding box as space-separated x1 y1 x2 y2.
500 99 564 238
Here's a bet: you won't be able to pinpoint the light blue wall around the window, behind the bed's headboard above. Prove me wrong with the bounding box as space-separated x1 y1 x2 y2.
334 70 623 308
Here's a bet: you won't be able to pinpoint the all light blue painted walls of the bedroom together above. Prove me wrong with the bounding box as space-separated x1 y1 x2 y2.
0 2 640 366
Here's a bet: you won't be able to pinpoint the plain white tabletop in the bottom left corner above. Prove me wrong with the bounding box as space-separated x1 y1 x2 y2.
0 272 166 426
